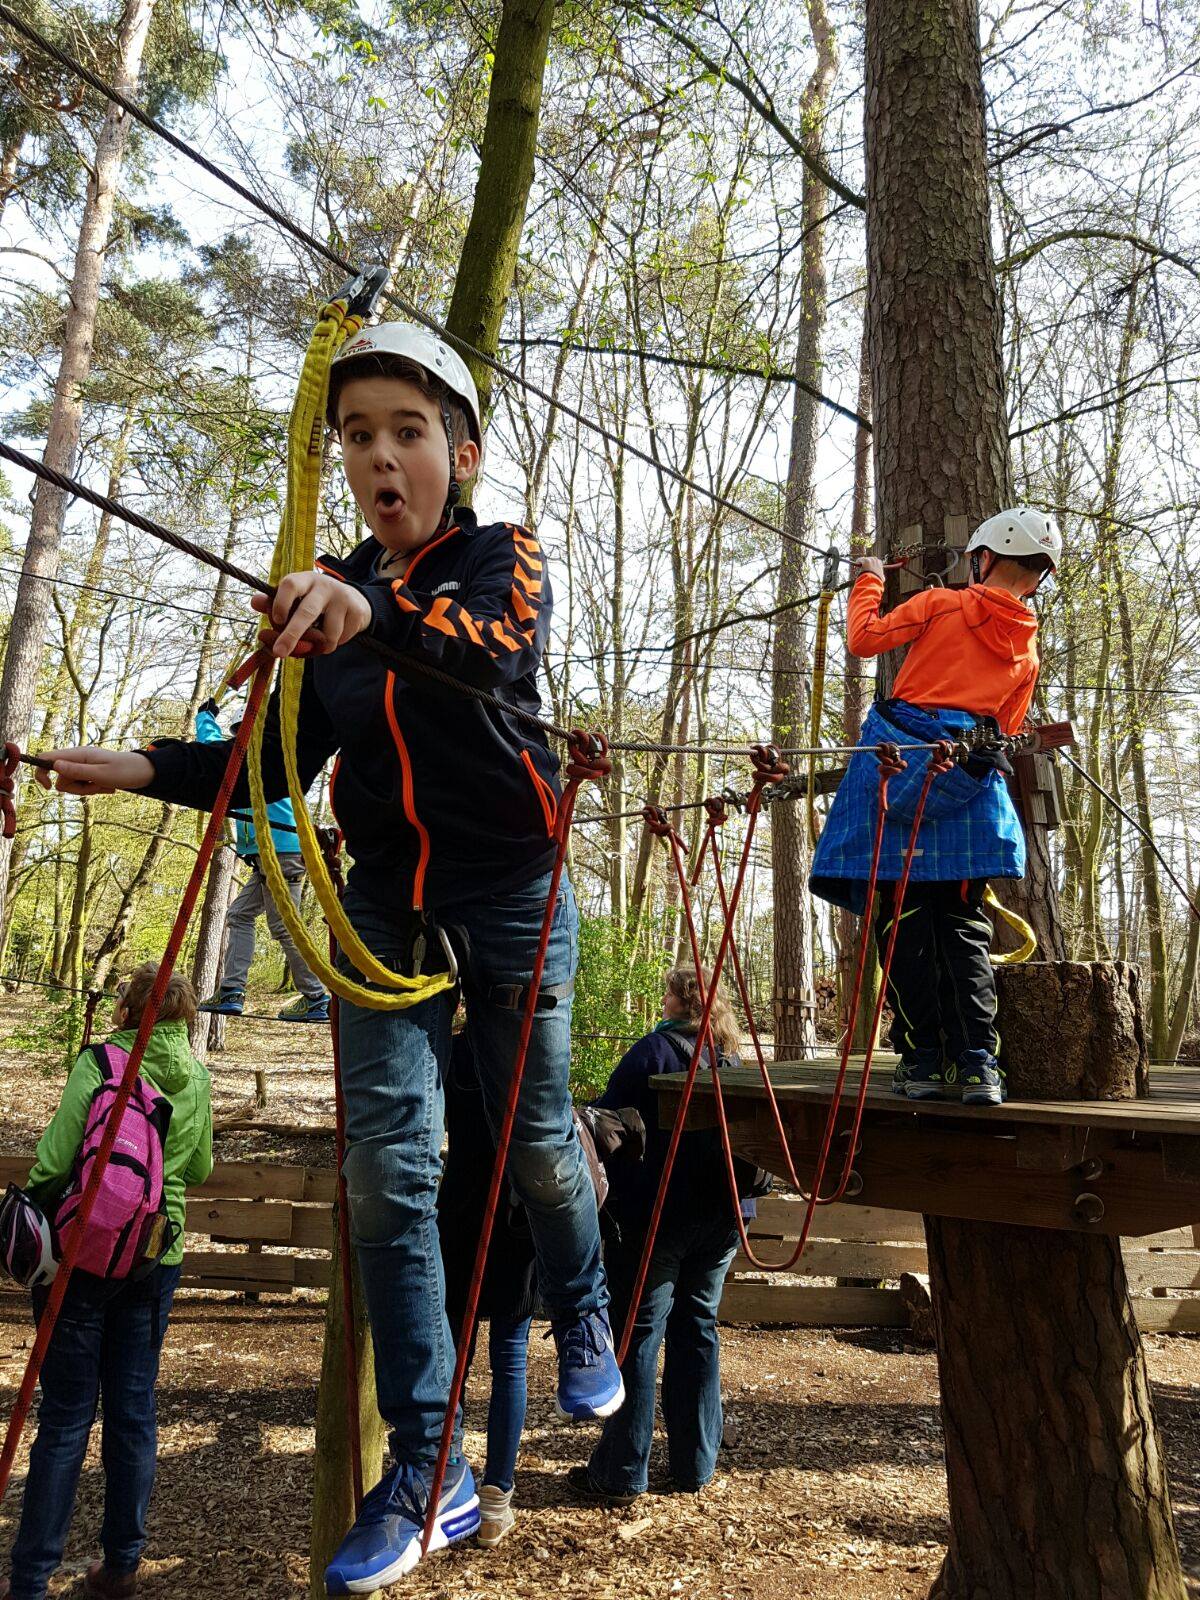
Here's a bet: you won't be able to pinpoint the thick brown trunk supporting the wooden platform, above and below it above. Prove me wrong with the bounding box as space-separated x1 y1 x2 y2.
866 0 1184 1600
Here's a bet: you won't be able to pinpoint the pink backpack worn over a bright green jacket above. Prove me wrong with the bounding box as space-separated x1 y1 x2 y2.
54 1045 173 1278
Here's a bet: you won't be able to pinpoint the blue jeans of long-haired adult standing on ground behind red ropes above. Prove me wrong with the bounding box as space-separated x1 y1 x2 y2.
589 1216 738 1494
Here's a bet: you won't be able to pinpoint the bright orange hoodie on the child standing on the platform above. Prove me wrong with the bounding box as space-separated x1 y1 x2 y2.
846 573 1038 733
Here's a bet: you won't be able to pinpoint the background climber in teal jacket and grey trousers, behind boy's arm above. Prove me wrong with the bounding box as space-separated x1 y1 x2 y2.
195 699 330 1022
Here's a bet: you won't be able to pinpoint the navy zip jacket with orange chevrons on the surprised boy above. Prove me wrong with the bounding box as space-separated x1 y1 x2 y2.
146 509 560 912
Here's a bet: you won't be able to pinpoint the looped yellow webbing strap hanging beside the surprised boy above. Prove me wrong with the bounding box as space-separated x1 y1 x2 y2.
246 288 451 1011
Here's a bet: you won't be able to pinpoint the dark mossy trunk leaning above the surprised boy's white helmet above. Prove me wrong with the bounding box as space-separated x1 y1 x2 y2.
446 0 555 416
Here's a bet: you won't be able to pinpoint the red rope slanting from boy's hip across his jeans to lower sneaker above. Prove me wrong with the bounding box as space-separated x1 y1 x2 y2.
421 730 611 1557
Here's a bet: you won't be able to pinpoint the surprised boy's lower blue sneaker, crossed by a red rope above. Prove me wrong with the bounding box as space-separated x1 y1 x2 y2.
325 1456 480 1595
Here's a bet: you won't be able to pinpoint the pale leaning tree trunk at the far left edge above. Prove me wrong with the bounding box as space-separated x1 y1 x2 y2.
0 0 154 910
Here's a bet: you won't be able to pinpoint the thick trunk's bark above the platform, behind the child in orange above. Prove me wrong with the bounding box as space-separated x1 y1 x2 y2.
866 0 1067 960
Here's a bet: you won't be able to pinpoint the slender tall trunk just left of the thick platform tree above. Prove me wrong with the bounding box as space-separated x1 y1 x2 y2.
771 0 838 1061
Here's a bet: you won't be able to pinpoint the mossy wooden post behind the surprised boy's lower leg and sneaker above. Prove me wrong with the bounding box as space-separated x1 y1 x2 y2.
309 1213 387 1600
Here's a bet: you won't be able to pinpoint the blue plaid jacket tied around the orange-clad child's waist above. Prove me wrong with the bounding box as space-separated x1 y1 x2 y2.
808 702 1026 915
